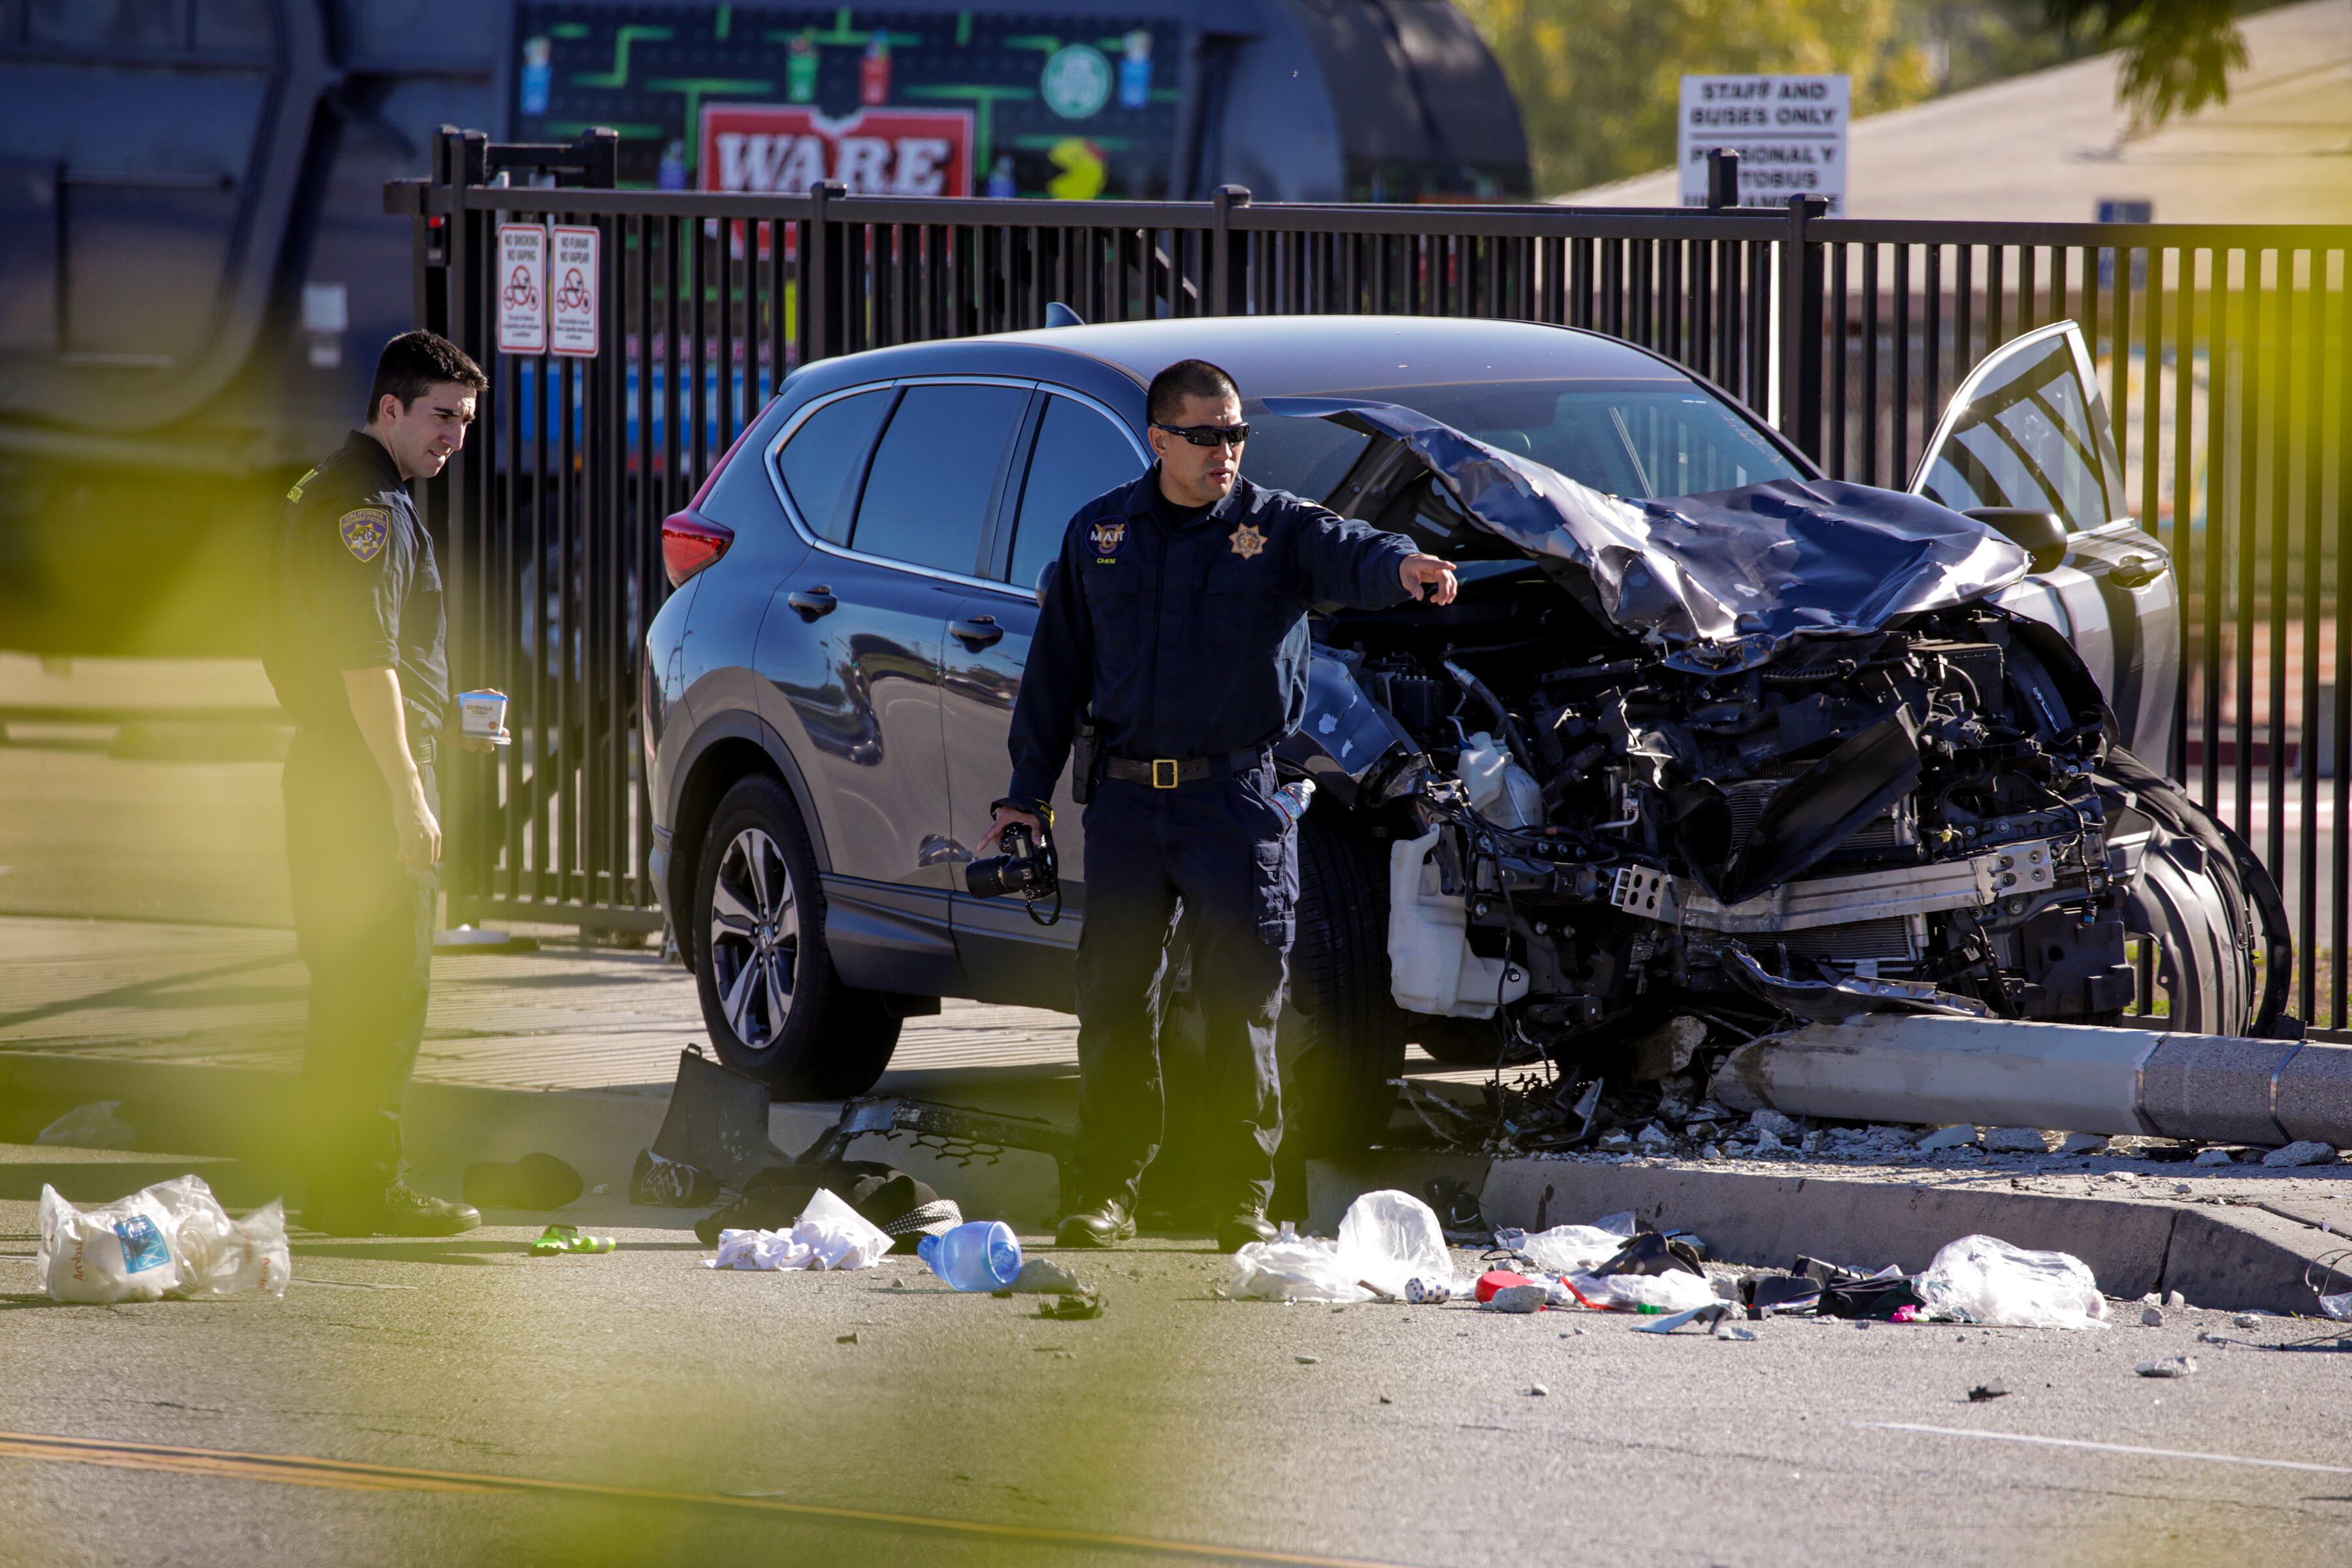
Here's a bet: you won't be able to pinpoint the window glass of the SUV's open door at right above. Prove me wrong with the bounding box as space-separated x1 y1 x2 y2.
1919 338 2112 531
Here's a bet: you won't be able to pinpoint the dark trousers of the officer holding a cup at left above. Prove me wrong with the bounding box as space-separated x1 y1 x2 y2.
285 731 440 1196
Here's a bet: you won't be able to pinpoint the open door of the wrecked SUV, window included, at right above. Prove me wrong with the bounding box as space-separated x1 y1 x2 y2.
1910 322 2180 769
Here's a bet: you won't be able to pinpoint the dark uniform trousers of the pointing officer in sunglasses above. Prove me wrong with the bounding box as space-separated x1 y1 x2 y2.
1077 764 1298 1206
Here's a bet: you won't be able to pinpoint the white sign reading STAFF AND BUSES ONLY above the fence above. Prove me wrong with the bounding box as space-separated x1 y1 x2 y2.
1677 75 1854 219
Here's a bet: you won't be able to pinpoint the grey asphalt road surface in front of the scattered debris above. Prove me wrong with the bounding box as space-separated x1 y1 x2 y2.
0 1147 2352 1568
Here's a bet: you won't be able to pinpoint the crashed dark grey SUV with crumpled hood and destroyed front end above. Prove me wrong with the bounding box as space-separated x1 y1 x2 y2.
644 318 2289 1140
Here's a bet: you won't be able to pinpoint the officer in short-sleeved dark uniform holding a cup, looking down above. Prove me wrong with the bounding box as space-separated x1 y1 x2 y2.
263 331 491 1237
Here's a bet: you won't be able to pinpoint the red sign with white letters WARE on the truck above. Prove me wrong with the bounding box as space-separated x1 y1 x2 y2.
698 103 972 195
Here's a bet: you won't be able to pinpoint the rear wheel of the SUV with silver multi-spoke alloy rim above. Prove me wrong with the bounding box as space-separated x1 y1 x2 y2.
694 776 898 1100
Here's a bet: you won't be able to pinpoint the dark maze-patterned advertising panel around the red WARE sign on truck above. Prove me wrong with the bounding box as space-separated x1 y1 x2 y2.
510 0 1185 200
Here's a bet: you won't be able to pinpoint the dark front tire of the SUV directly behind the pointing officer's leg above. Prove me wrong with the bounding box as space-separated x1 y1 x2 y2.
1284 811 1407 1159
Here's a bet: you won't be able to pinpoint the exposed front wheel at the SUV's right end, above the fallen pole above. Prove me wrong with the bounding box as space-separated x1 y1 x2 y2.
2100 747 2296 1039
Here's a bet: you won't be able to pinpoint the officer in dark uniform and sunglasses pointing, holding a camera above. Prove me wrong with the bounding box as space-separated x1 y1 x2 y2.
981 360 1454 1250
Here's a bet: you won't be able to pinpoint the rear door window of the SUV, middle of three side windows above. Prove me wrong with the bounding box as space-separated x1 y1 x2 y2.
849 385 1030 576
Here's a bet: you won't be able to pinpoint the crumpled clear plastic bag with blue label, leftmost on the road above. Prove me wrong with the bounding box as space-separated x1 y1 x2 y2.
33 1175 294 1302
